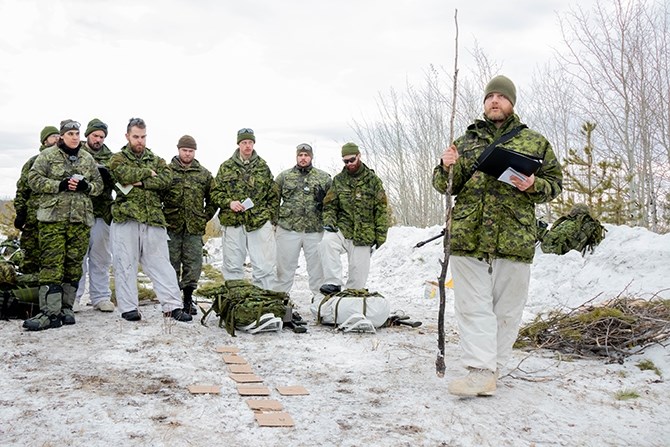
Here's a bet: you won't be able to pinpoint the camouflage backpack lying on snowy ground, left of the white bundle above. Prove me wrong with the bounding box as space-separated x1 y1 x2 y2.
201 280 290 337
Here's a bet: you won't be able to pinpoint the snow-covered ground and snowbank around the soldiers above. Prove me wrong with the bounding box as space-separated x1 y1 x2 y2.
0 226 670 447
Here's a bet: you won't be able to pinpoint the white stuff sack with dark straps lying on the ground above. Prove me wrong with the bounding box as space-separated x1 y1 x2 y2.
310 290 391 328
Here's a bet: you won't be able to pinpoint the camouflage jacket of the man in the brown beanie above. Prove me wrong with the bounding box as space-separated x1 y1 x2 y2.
163 156 216 235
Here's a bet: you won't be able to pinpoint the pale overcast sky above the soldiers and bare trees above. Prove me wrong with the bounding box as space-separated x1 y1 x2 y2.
0 0 592 197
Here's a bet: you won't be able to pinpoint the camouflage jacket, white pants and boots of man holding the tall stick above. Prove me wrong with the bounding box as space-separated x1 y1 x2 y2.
433 114 562 374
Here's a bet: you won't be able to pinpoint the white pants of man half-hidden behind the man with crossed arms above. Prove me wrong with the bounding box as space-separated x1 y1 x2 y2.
75 217 112 305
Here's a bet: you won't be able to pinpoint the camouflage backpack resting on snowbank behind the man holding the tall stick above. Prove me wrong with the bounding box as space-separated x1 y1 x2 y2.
541 204 607 256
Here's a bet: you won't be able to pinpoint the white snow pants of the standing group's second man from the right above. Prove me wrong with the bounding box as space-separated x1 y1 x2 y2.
275 226 324 295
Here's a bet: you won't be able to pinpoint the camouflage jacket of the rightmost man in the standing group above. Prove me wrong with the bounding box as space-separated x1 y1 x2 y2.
323 163 389 246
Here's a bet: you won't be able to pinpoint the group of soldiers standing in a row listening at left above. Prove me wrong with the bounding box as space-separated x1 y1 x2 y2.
14 118 388 330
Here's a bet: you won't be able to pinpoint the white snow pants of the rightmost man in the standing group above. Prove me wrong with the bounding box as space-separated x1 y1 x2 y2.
319 231 371 289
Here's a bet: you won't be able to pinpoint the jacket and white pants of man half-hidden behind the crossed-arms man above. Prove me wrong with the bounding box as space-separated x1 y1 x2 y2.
76 142 114 306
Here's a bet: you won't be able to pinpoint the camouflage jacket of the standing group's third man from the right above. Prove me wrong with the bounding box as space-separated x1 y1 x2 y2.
212 149 279 231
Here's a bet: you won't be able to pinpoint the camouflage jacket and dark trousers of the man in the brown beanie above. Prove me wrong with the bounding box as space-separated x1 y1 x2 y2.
163 156 217 290
